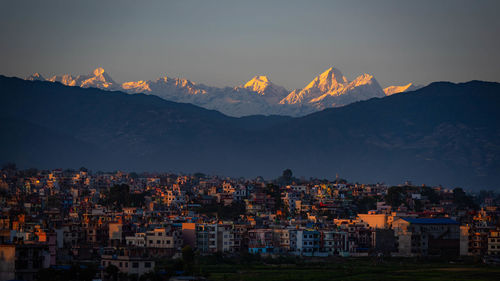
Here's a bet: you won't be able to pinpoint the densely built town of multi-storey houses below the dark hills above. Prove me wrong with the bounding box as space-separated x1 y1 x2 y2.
0 164 500 280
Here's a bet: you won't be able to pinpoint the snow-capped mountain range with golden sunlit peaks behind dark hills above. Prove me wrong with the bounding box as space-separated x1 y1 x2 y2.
26 67 418 117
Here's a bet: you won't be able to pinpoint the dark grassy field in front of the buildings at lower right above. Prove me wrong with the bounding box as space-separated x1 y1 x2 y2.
199 258 500 281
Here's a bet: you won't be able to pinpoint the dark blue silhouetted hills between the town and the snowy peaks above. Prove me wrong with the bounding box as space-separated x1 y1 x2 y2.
0 76 500 188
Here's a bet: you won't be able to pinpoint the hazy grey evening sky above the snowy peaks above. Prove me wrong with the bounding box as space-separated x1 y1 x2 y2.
0 0 500 89
